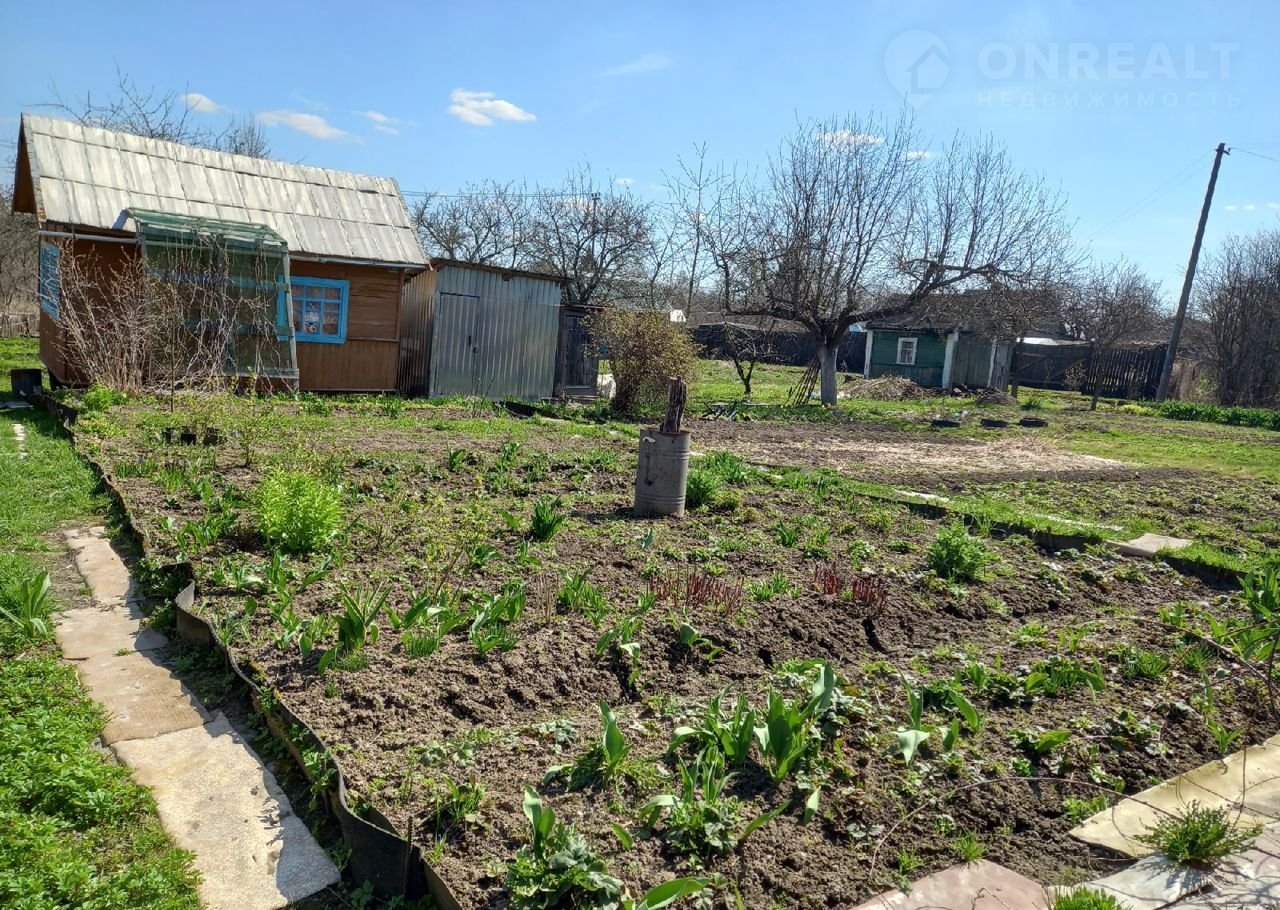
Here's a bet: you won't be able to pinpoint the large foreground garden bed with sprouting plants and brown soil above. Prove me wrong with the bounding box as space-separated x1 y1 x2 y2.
78 401 1274 907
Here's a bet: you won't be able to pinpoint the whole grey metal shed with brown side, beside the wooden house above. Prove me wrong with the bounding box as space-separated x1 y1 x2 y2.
399 259 594 401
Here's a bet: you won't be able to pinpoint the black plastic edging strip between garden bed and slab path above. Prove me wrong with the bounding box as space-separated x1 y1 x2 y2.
40 395 462 910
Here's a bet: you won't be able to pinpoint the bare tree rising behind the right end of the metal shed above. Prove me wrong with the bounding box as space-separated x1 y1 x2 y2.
529 165 652 306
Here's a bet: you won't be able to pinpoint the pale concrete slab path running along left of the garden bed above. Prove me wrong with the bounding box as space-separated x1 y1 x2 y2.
56 527 339 910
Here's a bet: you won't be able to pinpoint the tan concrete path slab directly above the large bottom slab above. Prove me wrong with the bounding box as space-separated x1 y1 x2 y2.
76 653 209 745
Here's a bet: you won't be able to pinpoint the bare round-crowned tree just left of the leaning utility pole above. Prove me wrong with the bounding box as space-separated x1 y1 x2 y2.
1064 260 1160 410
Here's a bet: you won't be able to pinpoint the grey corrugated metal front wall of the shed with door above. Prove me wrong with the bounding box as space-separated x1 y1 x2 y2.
428 265 561 401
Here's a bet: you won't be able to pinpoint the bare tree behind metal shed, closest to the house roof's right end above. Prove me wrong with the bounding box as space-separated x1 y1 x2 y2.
413 180 532 269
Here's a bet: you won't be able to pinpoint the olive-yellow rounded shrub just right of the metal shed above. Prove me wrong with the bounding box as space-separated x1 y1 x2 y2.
591 310 698 413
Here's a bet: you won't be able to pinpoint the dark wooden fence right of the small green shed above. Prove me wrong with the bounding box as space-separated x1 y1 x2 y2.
1014 343 1165 398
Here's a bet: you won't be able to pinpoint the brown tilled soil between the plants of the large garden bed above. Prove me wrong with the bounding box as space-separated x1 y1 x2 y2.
85 416 1274 907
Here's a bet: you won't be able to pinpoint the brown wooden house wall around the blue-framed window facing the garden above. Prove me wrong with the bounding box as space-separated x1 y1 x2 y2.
289 257 403 392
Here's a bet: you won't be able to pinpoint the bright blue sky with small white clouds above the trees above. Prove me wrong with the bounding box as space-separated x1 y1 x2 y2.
0 0 1280 298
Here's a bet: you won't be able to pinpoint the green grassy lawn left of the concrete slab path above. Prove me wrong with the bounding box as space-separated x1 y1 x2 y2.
0 409 198 910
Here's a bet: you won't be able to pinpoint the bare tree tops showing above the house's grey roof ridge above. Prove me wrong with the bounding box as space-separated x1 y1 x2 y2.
45 69 271 157
